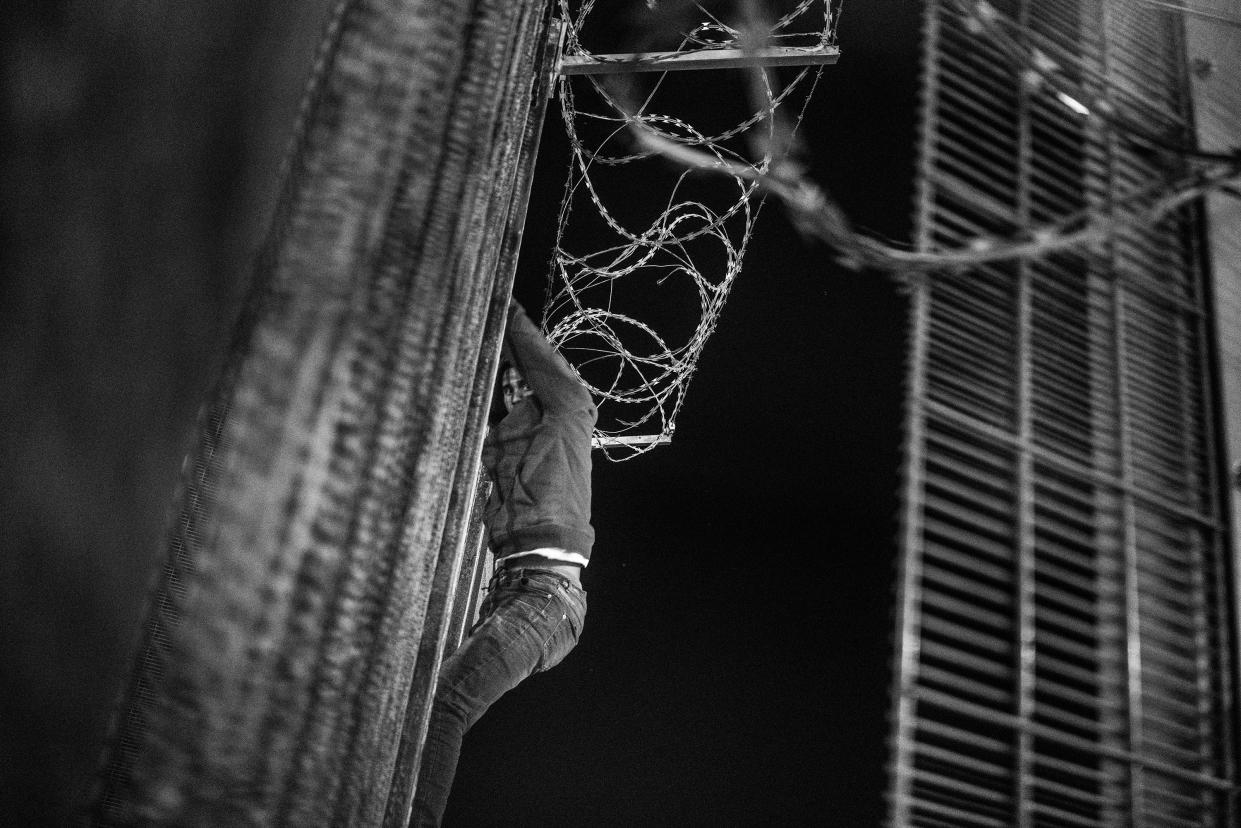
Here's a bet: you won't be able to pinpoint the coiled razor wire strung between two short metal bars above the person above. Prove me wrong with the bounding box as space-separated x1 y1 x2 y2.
544 0 843 461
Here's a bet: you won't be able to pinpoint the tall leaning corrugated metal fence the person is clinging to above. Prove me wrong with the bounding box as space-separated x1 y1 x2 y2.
91 0 550 826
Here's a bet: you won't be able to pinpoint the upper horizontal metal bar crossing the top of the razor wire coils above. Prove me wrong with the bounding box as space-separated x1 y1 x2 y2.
560 46 840 74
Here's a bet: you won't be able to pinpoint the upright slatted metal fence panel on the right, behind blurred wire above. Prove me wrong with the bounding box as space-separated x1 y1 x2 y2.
890 0 1239 828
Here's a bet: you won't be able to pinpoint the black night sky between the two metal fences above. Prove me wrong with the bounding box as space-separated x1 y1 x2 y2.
448 0 918 828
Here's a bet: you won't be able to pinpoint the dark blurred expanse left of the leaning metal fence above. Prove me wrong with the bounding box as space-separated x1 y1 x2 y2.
0 0 330 824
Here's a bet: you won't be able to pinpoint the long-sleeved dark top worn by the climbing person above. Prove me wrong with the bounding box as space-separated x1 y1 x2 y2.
483 302 597 560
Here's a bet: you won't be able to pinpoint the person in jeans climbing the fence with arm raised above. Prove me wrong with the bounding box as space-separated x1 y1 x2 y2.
413 300 597 826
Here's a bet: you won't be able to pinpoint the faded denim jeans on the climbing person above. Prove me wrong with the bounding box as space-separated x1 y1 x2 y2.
412 569 586 827
